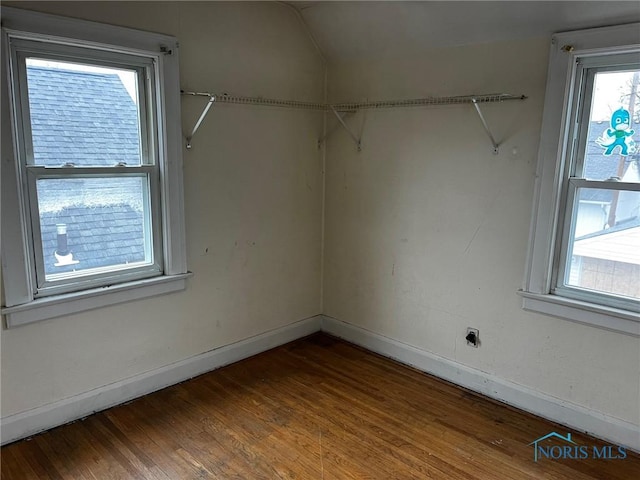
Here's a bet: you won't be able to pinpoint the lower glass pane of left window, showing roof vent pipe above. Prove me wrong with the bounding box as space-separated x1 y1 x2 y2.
37 176 153 281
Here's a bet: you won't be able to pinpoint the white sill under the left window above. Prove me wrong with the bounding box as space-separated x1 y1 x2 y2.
2 272 193 328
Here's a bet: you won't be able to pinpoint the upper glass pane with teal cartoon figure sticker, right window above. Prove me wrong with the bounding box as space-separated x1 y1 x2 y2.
582 70 640 182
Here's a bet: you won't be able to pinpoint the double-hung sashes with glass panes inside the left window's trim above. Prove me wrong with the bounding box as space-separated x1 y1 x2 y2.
11 39 163 297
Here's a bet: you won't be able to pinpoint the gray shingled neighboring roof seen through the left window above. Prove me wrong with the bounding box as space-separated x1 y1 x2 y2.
27 66 145 274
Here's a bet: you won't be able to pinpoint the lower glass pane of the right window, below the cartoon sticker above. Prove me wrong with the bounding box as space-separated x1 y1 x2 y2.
565 188 640 300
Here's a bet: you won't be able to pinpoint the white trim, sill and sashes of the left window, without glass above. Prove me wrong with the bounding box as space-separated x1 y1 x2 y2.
0 7 190 327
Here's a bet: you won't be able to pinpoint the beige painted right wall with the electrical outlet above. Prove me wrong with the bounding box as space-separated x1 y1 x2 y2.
324 38 640 425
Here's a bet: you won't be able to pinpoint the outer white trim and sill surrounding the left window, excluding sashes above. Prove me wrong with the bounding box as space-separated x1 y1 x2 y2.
0 7 190 327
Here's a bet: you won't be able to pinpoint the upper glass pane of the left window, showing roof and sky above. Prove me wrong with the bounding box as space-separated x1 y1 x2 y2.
26 58 141 166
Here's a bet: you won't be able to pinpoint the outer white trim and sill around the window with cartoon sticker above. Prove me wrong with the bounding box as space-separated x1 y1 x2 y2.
519 23 640 336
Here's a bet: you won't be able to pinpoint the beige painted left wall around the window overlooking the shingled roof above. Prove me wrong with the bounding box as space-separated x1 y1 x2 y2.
1 2 324 417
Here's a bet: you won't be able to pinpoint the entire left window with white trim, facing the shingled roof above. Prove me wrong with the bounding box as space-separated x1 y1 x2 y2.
2 8 186 326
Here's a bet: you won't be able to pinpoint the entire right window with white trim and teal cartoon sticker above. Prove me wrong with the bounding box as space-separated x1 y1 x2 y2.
521 24 640 335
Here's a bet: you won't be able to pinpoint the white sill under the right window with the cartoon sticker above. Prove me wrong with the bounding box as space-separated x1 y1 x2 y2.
518 290 640 337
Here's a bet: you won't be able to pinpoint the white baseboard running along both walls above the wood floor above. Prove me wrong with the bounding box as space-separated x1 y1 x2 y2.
6 315 640 452
